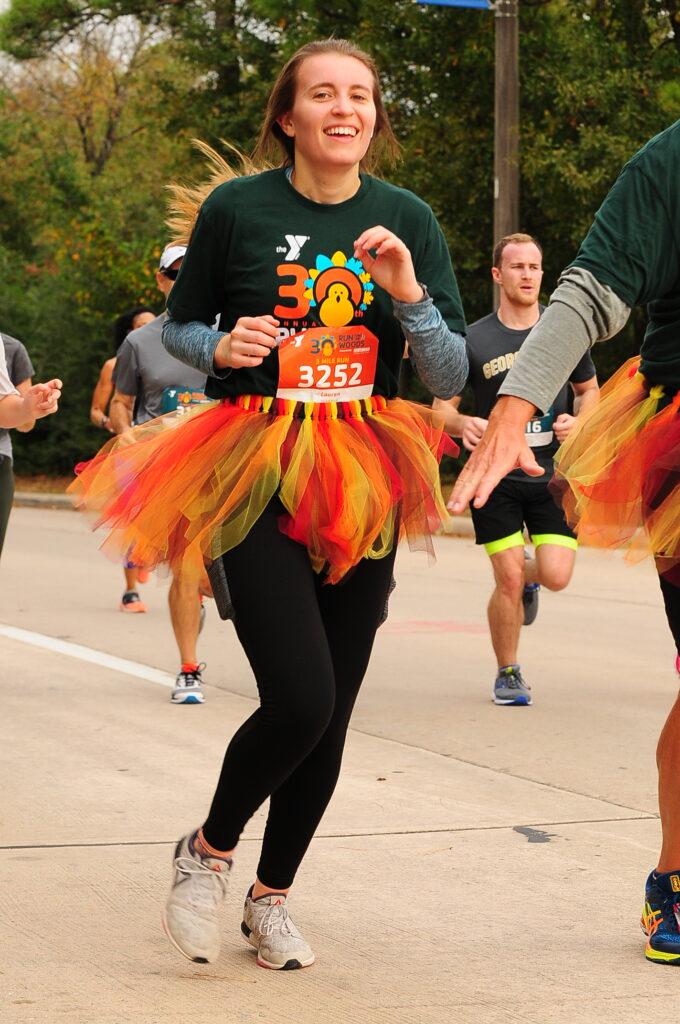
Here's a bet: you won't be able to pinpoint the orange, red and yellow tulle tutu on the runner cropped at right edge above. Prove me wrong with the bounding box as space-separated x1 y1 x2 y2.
551 357 680 582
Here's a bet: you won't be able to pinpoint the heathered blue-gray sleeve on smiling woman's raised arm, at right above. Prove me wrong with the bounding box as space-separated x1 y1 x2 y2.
392 286 468 398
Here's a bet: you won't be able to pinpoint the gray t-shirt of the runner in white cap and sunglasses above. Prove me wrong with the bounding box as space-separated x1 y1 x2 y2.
113 313 206 423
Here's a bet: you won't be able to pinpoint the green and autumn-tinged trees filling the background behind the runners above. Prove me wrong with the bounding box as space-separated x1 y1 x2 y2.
0 0 680 472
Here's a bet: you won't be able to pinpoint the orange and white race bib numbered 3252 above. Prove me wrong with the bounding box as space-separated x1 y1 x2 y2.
277 325 378 402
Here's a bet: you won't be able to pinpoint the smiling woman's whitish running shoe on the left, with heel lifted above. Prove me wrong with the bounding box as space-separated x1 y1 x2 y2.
163 833 231 964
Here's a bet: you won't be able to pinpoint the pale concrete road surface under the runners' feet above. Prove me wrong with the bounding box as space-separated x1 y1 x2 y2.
0 508 677 1024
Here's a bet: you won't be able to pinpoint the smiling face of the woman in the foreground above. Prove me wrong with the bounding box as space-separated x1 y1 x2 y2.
279 53 376 171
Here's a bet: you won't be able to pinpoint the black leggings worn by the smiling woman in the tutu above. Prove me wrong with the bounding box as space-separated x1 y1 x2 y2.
204 502 394 889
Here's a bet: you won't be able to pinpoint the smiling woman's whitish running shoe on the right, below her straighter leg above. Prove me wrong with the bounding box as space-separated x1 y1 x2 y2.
241 886 314 971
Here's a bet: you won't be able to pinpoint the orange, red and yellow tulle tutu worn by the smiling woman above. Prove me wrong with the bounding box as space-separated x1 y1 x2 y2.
69 395 458 583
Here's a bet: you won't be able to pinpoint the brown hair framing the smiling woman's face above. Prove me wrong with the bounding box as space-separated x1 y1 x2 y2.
253 39 399 171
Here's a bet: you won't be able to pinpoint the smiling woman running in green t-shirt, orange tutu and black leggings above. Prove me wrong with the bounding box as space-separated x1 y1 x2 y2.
69 40 467 969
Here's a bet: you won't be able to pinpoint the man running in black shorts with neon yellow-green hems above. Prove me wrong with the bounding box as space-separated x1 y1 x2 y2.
434 234 599 706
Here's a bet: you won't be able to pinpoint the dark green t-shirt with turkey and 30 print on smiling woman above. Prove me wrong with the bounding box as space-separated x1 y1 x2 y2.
168 169 465 398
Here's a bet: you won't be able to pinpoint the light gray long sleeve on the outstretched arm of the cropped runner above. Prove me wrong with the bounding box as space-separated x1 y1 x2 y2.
499 266 631 412
